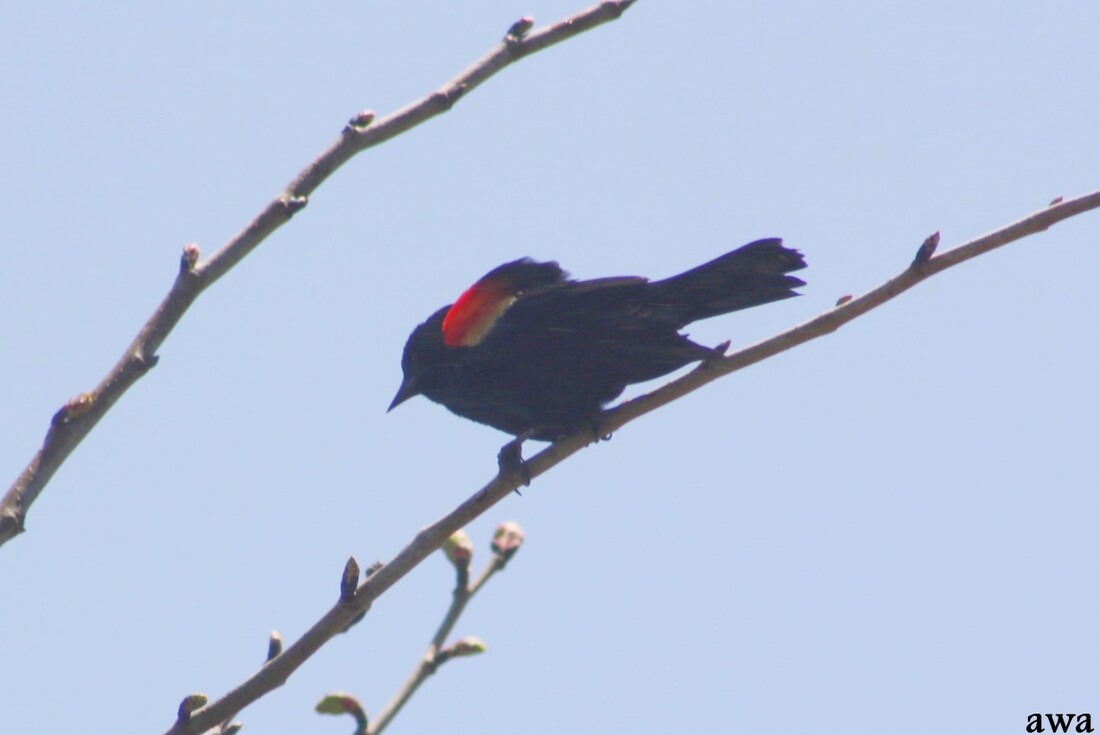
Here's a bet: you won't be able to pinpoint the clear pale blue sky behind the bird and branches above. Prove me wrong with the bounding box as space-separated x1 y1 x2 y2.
0 0 1100 735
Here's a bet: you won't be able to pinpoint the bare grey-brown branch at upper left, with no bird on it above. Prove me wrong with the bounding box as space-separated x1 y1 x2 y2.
0 0 635 546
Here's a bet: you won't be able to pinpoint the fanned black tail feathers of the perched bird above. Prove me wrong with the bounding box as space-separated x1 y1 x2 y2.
649 238 806 327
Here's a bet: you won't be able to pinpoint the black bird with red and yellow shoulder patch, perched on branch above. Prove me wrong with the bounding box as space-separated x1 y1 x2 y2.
387 238 806 442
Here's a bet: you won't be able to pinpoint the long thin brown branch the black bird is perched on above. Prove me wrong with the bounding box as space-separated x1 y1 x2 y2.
159 191 1100 735
